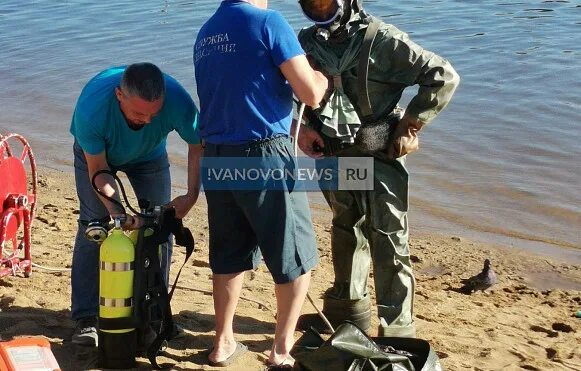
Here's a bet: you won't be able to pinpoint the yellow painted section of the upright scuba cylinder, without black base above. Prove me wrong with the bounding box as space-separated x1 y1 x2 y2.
99 227 135 333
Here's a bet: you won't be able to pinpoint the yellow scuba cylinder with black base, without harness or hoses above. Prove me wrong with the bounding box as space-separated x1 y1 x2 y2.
98 219 137 368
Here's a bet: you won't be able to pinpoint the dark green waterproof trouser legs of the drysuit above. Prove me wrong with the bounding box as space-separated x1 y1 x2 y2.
323 146 415 336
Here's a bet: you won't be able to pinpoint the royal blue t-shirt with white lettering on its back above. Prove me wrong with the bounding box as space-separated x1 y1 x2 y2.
194 1 304 144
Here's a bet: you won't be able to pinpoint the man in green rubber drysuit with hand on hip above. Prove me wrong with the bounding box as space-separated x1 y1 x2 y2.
298 0 460 337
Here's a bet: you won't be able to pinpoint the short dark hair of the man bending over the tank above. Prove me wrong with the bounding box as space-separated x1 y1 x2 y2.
121 62 165 102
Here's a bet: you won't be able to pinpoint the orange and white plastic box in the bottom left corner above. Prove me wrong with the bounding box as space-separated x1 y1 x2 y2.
0 337 60 371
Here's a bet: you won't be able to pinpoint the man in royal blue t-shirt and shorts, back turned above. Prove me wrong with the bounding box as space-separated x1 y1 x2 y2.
193 0 328 367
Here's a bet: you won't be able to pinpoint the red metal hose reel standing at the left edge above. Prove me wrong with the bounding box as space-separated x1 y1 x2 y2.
0 134 36 277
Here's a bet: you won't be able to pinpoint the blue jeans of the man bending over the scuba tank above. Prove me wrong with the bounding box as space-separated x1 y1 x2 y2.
71 142 173 320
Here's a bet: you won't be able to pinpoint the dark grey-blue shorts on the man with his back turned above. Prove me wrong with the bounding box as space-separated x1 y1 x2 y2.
202 137 319 284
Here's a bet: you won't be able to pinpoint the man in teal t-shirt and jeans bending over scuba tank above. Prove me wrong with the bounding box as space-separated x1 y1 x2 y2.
70 63 202 346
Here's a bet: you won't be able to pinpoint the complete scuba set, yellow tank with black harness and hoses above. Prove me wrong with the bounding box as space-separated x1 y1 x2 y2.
86 170 195 369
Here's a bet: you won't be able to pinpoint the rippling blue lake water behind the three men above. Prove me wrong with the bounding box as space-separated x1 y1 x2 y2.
0 0 581 263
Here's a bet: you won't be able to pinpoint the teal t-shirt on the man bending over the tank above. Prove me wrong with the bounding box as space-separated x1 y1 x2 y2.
70 66 200 166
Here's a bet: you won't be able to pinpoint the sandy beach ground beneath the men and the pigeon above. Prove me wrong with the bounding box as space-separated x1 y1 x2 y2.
0 168 581 370
